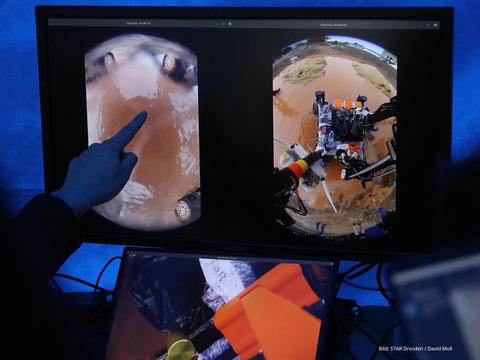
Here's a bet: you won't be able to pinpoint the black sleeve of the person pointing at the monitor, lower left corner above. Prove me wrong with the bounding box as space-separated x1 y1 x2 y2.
0 195 88 360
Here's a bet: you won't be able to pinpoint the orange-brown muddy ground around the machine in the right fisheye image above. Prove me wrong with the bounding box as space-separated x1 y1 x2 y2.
273 43 396 236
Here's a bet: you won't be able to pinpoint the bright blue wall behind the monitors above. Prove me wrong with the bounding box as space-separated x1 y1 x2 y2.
0 0 480 303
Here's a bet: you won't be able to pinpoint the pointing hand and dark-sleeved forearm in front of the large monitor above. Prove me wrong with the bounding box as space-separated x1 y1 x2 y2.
4 112 147 284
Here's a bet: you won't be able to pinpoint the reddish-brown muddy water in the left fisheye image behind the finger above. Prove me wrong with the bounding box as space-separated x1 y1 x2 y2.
87 36 200 231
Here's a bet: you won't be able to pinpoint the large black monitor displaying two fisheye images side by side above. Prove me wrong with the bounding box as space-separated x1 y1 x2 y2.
36 6 453 258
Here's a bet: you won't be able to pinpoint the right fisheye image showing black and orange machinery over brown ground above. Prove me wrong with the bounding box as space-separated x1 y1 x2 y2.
273 36 397 242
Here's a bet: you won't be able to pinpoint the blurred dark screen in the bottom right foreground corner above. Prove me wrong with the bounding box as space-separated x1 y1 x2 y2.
389 243 480 360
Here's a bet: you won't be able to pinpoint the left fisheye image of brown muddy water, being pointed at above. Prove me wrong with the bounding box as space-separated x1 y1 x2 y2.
85 34 201 231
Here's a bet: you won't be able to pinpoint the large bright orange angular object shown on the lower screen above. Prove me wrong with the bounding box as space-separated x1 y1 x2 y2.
213 264 321 360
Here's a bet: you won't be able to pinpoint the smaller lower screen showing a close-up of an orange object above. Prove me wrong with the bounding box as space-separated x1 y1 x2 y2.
106 250 336 360
